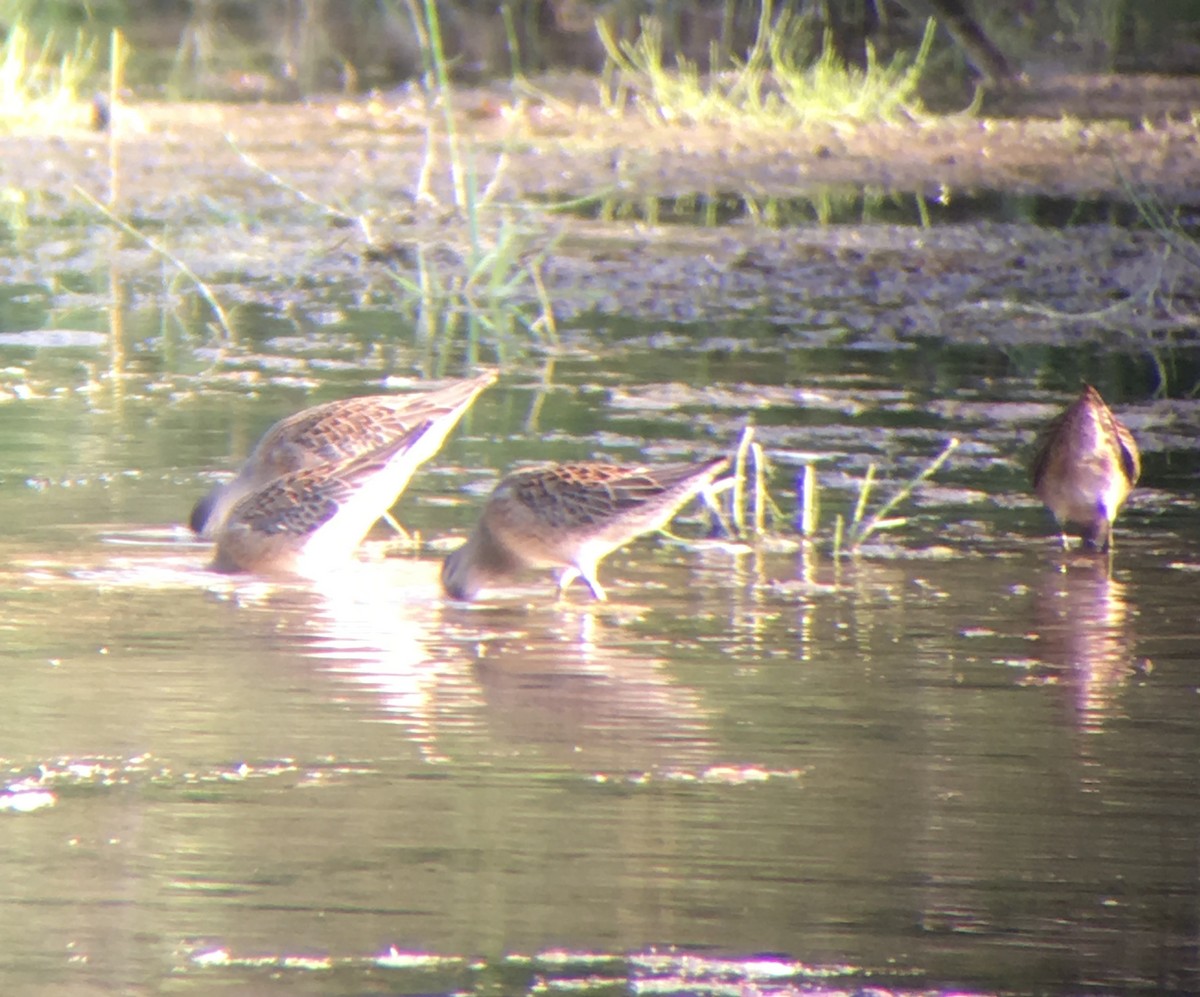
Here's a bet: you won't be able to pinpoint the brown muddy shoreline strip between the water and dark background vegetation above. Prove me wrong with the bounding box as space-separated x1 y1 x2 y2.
2 77 1200 346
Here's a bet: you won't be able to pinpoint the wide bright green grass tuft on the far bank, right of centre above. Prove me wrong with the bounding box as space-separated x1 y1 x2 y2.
598 0 934 126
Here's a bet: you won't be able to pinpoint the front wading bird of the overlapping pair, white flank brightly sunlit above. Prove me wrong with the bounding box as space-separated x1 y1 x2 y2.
212 420 439 576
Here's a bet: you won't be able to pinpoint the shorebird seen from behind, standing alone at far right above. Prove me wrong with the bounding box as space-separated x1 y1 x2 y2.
1032 384 1141 551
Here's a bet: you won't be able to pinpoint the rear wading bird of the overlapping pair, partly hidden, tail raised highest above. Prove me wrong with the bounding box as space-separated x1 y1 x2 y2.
188 371 496 540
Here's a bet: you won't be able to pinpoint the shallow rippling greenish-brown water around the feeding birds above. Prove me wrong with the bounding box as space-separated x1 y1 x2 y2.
0 305 1200 995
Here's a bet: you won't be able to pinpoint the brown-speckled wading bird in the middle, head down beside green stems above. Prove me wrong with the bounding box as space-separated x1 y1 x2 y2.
442 457 728 600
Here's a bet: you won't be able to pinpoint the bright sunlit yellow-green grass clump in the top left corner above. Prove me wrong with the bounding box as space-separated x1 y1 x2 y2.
0 22 96 130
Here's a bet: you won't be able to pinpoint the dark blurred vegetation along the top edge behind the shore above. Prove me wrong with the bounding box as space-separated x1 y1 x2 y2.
0 0 1200 100
